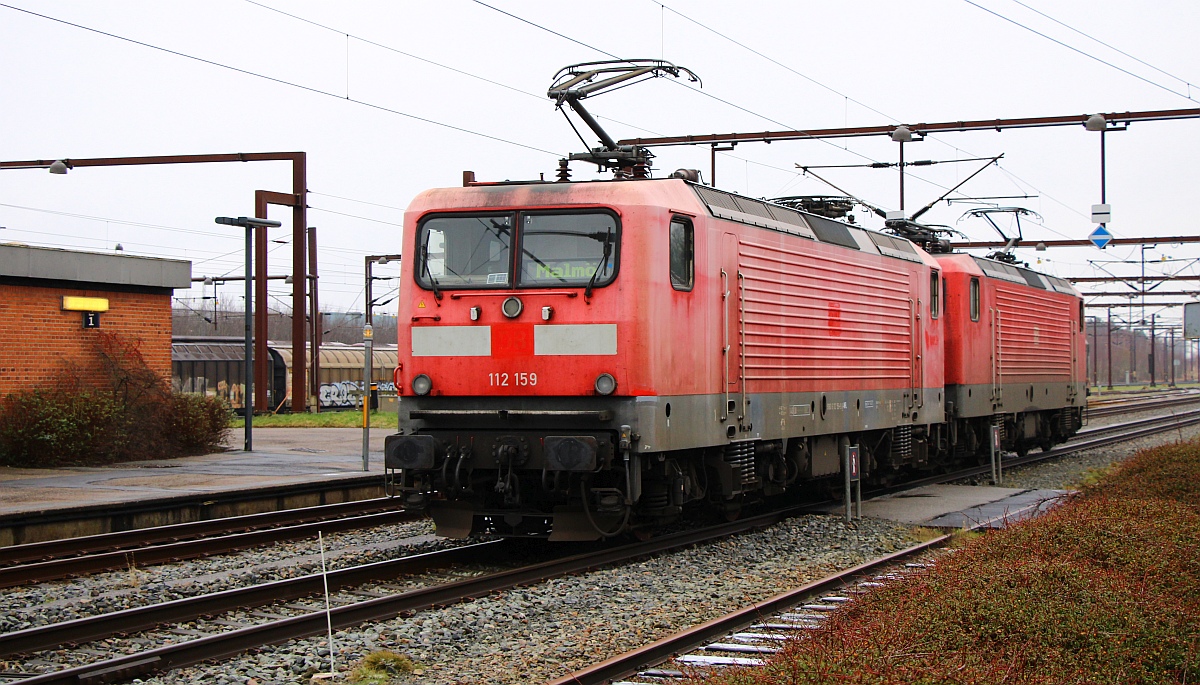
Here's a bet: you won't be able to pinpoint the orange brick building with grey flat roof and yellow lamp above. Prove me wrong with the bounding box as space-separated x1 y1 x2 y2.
0 245 192 396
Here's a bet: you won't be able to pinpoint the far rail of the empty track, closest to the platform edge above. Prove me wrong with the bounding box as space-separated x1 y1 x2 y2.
0 499 408 567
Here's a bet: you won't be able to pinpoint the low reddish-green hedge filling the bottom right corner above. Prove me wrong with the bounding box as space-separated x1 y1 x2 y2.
709 443 1200 685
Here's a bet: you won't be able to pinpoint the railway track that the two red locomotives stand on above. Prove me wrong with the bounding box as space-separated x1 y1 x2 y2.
0 410 1200 683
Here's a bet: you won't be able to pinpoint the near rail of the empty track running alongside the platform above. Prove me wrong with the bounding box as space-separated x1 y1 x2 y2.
0 510 424 588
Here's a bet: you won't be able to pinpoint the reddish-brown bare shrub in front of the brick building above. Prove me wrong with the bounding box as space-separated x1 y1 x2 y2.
0 334 230 468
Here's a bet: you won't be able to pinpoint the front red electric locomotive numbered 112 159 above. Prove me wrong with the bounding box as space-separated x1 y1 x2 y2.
386 179 944 540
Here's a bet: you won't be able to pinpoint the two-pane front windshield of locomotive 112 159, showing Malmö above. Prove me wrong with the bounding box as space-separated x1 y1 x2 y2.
415 211 618 290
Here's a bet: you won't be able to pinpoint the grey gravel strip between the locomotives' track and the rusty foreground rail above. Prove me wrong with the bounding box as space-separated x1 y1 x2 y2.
138 516 913 685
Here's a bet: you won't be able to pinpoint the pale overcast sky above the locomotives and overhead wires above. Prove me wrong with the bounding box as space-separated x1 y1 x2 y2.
0 0 1200 321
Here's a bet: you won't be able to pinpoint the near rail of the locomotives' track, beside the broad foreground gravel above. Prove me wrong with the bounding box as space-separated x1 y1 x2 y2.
11 506 809 685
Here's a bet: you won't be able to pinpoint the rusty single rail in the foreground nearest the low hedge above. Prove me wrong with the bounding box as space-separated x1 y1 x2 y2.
548 535 952 685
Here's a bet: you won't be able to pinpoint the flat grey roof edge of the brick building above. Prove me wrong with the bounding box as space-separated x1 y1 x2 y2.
0 244 192 289
